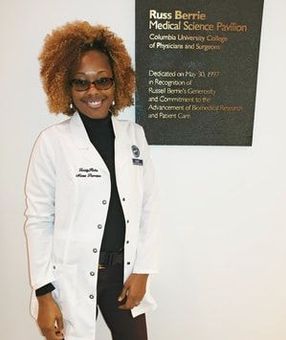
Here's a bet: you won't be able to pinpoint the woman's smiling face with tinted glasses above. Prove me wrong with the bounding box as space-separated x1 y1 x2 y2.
71 50 114 118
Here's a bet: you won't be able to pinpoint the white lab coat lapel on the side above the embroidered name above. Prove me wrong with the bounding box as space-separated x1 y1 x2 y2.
70 112 109 173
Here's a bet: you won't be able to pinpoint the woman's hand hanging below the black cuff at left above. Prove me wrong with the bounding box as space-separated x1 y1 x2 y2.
37 293 64 340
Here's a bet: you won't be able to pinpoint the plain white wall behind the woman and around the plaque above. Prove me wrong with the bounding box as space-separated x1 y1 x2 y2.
0 0 286 340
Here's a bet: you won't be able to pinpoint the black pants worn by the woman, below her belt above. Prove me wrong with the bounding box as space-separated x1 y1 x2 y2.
97 264 147 340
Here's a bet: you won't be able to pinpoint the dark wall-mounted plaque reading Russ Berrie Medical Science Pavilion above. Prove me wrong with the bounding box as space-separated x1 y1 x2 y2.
136 0 263 145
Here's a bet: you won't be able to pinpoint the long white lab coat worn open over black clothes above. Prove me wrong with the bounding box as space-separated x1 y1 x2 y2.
25 113 158 340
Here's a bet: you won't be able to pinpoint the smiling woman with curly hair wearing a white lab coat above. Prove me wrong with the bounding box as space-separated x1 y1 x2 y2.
25 21 157 340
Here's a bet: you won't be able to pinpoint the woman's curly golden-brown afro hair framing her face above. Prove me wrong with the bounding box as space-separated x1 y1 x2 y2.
39 21 135 116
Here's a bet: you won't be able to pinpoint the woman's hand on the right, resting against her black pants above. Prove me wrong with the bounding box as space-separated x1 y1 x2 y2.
118 274 148 309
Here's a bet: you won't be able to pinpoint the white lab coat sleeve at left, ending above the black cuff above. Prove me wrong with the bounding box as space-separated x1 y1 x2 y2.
25 132 56 290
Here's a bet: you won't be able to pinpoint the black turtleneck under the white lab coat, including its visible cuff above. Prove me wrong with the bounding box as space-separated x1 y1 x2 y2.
36 113 125 296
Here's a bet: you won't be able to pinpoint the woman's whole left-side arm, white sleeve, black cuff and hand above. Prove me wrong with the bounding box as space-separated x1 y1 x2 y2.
25 133 63 340
